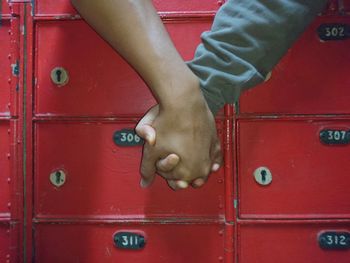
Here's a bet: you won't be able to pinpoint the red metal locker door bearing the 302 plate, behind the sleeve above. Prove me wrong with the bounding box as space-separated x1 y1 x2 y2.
240 15 350 114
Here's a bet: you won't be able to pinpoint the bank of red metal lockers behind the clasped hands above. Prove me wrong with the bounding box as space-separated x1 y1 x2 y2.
0 0 350 263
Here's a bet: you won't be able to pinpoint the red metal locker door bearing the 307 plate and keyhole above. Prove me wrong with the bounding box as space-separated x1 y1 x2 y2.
238 119 350 218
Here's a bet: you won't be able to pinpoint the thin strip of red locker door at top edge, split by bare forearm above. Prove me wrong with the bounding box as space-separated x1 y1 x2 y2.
34 0 224 16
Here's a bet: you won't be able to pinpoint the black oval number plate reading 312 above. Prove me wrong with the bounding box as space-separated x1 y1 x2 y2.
318 232 350 249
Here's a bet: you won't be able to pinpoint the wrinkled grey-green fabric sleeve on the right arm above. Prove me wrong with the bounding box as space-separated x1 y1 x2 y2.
188 0 326 114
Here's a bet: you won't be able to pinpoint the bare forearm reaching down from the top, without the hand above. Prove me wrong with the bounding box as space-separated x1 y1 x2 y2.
72 0 200 107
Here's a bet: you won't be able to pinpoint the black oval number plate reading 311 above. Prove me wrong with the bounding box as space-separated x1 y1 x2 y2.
114 232 146 250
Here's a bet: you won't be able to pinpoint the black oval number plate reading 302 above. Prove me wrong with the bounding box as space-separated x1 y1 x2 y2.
317 24 350 41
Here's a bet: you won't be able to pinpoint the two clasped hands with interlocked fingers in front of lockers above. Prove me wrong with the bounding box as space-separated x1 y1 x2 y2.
136 98 222 190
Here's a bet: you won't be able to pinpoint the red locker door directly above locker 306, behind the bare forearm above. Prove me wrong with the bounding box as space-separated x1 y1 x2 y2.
35 21 210 116
